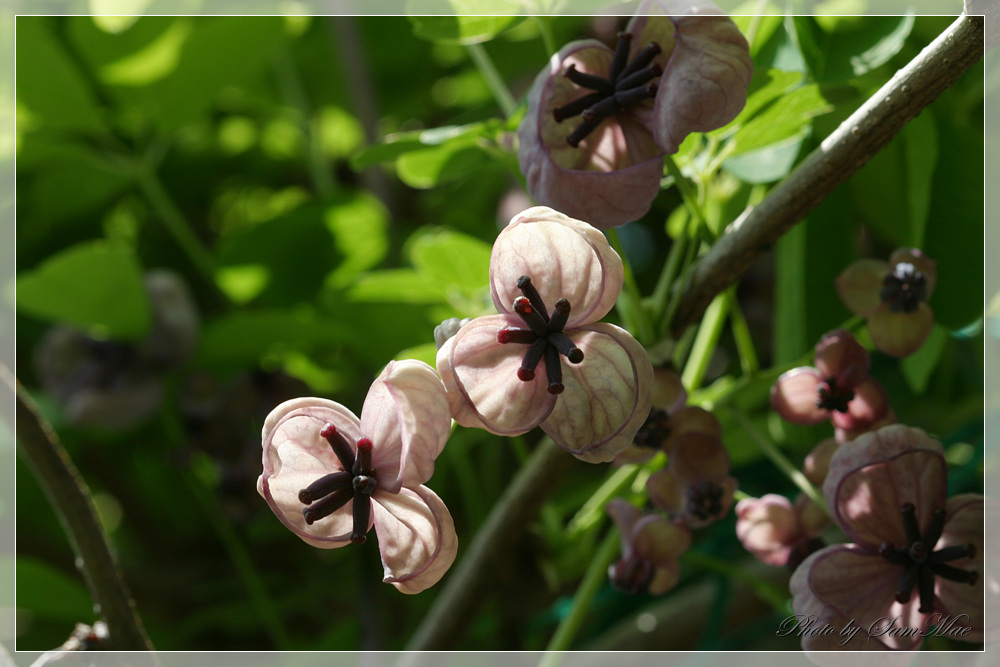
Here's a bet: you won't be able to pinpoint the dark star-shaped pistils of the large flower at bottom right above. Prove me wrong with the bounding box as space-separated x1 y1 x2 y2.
878 503 979 614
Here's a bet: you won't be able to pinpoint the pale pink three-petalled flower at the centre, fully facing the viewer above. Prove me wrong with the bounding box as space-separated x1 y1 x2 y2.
437 207 653 462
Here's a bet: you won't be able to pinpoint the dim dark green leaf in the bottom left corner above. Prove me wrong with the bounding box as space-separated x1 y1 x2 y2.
9 556 94 623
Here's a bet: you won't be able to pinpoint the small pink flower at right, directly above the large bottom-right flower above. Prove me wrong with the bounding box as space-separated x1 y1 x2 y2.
771 329 889 431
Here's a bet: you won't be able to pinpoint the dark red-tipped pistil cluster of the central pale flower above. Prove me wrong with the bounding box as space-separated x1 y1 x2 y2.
497 276 583 394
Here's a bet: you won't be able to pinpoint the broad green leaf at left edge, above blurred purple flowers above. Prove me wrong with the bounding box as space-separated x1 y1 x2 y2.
17 241 150 340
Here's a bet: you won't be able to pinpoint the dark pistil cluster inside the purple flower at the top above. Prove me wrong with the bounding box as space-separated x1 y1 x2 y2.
552 32 663 148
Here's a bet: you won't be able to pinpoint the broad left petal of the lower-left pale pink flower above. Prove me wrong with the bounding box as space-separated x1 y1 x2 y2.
257 398 360 549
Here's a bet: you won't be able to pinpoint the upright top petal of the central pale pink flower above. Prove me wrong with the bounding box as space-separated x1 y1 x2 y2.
490 206 625 329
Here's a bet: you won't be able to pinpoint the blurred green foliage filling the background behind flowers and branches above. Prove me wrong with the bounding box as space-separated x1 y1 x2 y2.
15 7 983 650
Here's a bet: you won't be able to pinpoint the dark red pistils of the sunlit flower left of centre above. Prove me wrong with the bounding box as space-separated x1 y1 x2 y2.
299 424 378 544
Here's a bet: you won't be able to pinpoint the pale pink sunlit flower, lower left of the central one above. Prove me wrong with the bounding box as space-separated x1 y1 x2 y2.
257 361 458 593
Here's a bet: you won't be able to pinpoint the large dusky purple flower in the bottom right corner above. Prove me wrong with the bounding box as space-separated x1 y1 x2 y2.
790 424 995 650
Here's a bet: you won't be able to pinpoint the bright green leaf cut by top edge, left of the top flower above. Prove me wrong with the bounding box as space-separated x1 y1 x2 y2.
406 0 521 44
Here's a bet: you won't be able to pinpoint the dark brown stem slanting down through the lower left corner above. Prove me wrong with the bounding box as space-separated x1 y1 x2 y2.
0 364 152 651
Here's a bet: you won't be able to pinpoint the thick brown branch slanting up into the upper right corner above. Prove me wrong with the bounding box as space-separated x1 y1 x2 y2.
671 15 984 337
